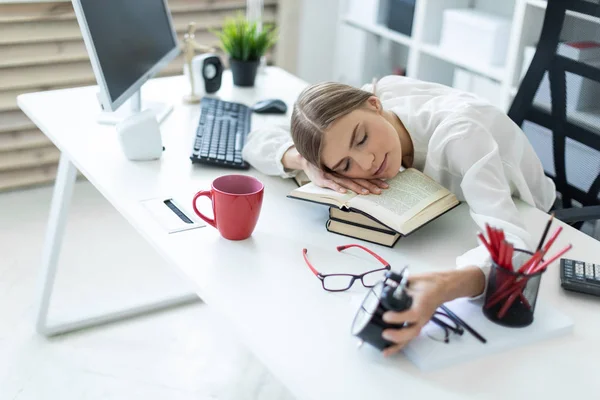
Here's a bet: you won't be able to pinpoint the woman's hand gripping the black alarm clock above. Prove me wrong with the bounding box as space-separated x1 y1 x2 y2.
383 273 445 356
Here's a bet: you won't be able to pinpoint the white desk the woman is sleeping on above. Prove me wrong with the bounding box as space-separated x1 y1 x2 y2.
19 68 600 400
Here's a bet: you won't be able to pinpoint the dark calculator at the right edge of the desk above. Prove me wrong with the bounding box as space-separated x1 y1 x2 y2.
560 258 600 296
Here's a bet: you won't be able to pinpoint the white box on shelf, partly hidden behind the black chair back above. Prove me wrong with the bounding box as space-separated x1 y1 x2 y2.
521 46 600 111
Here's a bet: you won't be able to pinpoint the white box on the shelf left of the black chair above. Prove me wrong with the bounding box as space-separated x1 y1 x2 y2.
440 8 511 66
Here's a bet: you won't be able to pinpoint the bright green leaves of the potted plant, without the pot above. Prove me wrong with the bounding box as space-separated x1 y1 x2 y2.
213 13 277 61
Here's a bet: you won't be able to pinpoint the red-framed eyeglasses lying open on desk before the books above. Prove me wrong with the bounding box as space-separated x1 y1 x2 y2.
302 244 391 292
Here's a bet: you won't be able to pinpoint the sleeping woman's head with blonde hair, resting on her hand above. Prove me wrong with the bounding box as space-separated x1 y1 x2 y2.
292 82 402 179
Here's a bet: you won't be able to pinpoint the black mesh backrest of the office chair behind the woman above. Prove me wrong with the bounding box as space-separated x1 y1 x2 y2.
508 0 600 211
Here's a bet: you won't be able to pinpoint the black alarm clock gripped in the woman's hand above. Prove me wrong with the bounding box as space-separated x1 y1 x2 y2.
351 268 412 350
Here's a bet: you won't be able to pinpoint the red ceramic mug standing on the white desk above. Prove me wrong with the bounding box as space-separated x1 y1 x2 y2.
192 175 264 240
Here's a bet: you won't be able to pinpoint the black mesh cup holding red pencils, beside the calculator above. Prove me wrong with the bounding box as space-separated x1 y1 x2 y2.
483 249 545 328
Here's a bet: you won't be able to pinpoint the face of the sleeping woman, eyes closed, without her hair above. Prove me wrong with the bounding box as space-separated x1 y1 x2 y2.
321 97 402 179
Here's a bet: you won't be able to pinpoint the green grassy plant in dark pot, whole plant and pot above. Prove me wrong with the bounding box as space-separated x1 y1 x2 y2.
215 14 277 86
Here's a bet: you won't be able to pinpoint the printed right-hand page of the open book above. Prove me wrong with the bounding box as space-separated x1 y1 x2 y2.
349 168 449 233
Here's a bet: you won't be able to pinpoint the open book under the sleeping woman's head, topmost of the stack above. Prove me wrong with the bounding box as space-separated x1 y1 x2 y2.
288 168 460 236
